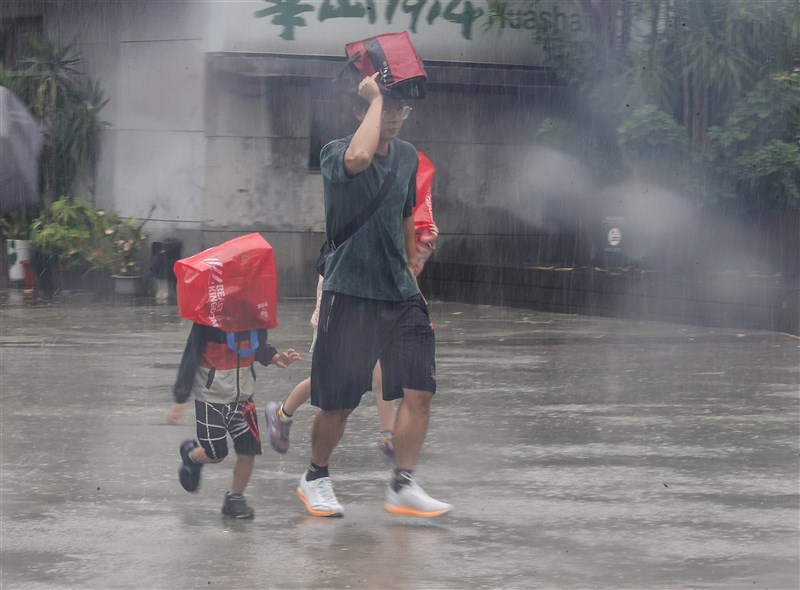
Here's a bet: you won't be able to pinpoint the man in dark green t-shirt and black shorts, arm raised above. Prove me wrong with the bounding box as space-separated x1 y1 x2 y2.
297 74 452 517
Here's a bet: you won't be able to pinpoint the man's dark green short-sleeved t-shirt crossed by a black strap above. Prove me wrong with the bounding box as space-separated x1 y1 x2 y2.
320 136 419 301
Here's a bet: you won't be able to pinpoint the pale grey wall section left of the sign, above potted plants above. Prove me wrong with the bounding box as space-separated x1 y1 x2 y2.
9 0 207 260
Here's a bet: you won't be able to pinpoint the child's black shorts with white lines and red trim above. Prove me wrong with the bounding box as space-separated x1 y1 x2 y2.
194 398 261 459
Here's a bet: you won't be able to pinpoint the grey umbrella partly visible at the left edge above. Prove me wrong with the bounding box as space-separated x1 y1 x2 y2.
0 86 43 214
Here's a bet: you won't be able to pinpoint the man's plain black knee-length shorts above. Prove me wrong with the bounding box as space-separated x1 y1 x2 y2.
311 291 436 410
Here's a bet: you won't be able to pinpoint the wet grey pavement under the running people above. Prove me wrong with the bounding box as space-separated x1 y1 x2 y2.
0 300 800 589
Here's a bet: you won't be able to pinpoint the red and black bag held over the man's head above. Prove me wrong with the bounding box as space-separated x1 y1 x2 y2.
344 31 428 98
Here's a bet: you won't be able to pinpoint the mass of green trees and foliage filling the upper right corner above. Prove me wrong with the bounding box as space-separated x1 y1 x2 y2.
485 0 800 209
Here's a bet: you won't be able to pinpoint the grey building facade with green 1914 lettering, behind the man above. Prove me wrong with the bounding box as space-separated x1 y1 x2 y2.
0 0 585 296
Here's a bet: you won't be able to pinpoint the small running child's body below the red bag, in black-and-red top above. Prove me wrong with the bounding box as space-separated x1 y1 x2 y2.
167 323 300 518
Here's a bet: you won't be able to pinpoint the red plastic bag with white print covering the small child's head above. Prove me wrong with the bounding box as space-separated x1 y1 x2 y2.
174 233 278 332
